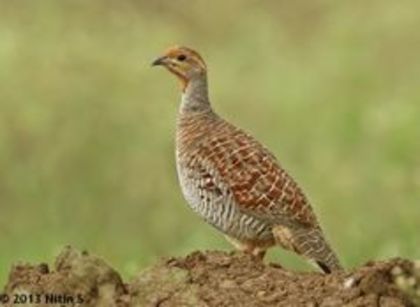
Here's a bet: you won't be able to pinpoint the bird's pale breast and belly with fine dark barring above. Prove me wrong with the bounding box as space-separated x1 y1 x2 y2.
176 116 272 241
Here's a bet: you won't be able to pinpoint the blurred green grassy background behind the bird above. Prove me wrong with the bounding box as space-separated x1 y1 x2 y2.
0 0 420 285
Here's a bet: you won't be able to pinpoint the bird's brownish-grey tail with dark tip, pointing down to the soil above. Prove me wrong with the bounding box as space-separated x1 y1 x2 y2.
273 226 343 274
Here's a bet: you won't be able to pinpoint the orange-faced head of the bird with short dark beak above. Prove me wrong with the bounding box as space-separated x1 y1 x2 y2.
152 46 207 91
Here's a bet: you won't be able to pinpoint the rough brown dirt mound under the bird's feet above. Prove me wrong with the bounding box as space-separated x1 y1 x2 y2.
0 247 420 307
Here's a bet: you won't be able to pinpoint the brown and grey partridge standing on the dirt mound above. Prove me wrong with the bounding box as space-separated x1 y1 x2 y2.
152 46 343 274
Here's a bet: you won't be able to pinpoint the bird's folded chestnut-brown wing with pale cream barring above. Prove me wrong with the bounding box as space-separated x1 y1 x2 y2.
197 122 317 227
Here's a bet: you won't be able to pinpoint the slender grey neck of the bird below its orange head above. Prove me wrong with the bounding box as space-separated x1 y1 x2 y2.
179 75 211 114
